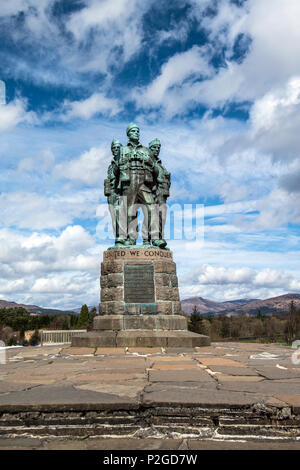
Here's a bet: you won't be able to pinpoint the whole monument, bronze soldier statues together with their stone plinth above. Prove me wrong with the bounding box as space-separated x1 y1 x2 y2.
72 123 210 348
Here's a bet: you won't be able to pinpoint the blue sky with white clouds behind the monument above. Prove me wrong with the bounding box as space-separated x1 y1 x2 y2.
0 0 300 309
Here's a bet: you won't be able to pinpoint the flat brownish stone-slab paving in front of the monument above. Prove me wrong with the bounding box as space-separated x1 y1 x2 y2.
0 343 300 449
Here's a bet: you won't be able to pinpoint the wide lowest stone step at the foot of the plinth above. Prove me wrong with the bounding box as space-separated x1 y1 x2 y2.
71 330 210 348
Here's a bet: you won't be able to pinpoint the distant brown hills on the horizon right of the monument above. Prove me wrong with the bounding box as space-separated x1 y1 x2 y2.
181 294 300 315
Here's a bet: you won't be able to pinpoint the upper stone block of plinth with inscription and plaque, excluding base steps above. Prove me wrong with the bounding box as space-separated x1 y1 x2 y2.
99 248 182 315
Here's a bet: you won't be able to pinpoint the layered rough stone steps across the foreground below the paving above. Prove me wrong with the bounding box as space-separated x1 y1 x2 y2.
0 403 300 443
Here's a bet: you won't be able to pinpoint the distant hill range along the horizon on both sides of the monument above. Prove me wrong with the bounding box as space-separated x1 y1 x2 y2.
0 294 300 315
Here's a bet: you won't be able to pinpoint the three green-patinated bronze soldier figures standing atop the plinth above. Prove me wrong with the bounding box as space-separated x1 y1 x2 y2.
104 123 171 248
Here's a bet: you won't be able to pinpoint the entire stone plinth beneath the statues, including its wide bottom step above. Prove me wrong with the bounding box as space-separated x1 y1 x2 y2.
72 247 210 347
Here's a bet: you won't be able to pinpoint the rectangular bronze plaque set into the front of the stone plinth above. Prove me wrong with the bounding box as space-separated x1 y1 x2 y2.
124 264 155 304
